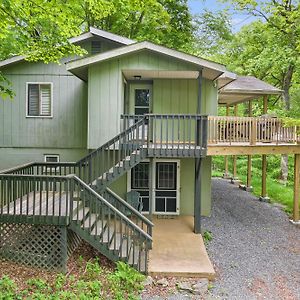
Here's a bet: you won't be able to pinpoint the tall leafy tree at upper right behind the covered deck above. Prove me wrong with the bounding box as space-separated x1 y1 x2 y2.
223 0 300 110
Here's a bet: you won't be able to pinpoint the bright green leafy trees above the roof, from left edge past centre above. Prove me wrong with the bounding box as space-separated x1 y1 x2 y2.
0 0 193 95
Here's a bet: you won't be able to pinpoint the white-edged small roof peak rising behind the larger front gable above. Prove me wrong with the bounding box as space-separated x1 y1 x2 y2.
69 27 136 45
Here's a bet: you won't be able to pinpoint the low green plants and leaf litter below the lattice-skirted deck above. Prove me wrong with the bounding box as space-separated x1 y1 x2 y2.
0 259 144 300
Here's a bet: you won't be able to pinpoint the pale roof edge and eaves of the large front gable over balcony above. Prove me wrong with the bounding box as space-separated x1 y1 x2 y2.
67 41 226 80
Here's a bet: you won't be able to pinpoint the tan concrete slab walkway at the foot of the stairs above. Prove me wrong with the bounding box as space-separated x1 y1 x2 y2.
149 216 215 280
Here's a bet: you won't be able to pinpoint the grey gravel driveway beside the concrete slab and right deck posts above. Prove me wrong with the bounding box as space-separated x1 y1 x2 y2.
202 179 300 300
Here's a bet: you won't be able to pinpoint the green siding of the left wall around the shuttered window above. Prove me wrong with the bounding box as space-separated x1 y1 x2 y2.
0 62 87 149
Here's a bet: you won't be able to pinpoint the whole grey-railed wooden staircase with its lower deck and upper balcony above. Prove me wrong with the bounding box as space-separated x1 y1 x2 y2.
0 115 207 273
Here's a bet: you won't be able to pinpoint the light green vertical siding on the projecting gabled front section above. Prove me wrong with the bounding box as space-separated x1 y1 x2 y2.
88 50 197 149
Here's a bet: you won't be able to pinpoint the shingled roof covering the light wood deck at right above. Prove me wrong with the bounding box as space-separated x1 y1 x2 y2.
219 76 282 105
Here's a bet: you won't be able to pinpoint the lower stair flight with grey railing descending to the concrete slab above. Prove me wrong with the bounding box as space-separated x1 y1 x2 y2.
70 177 153 273
